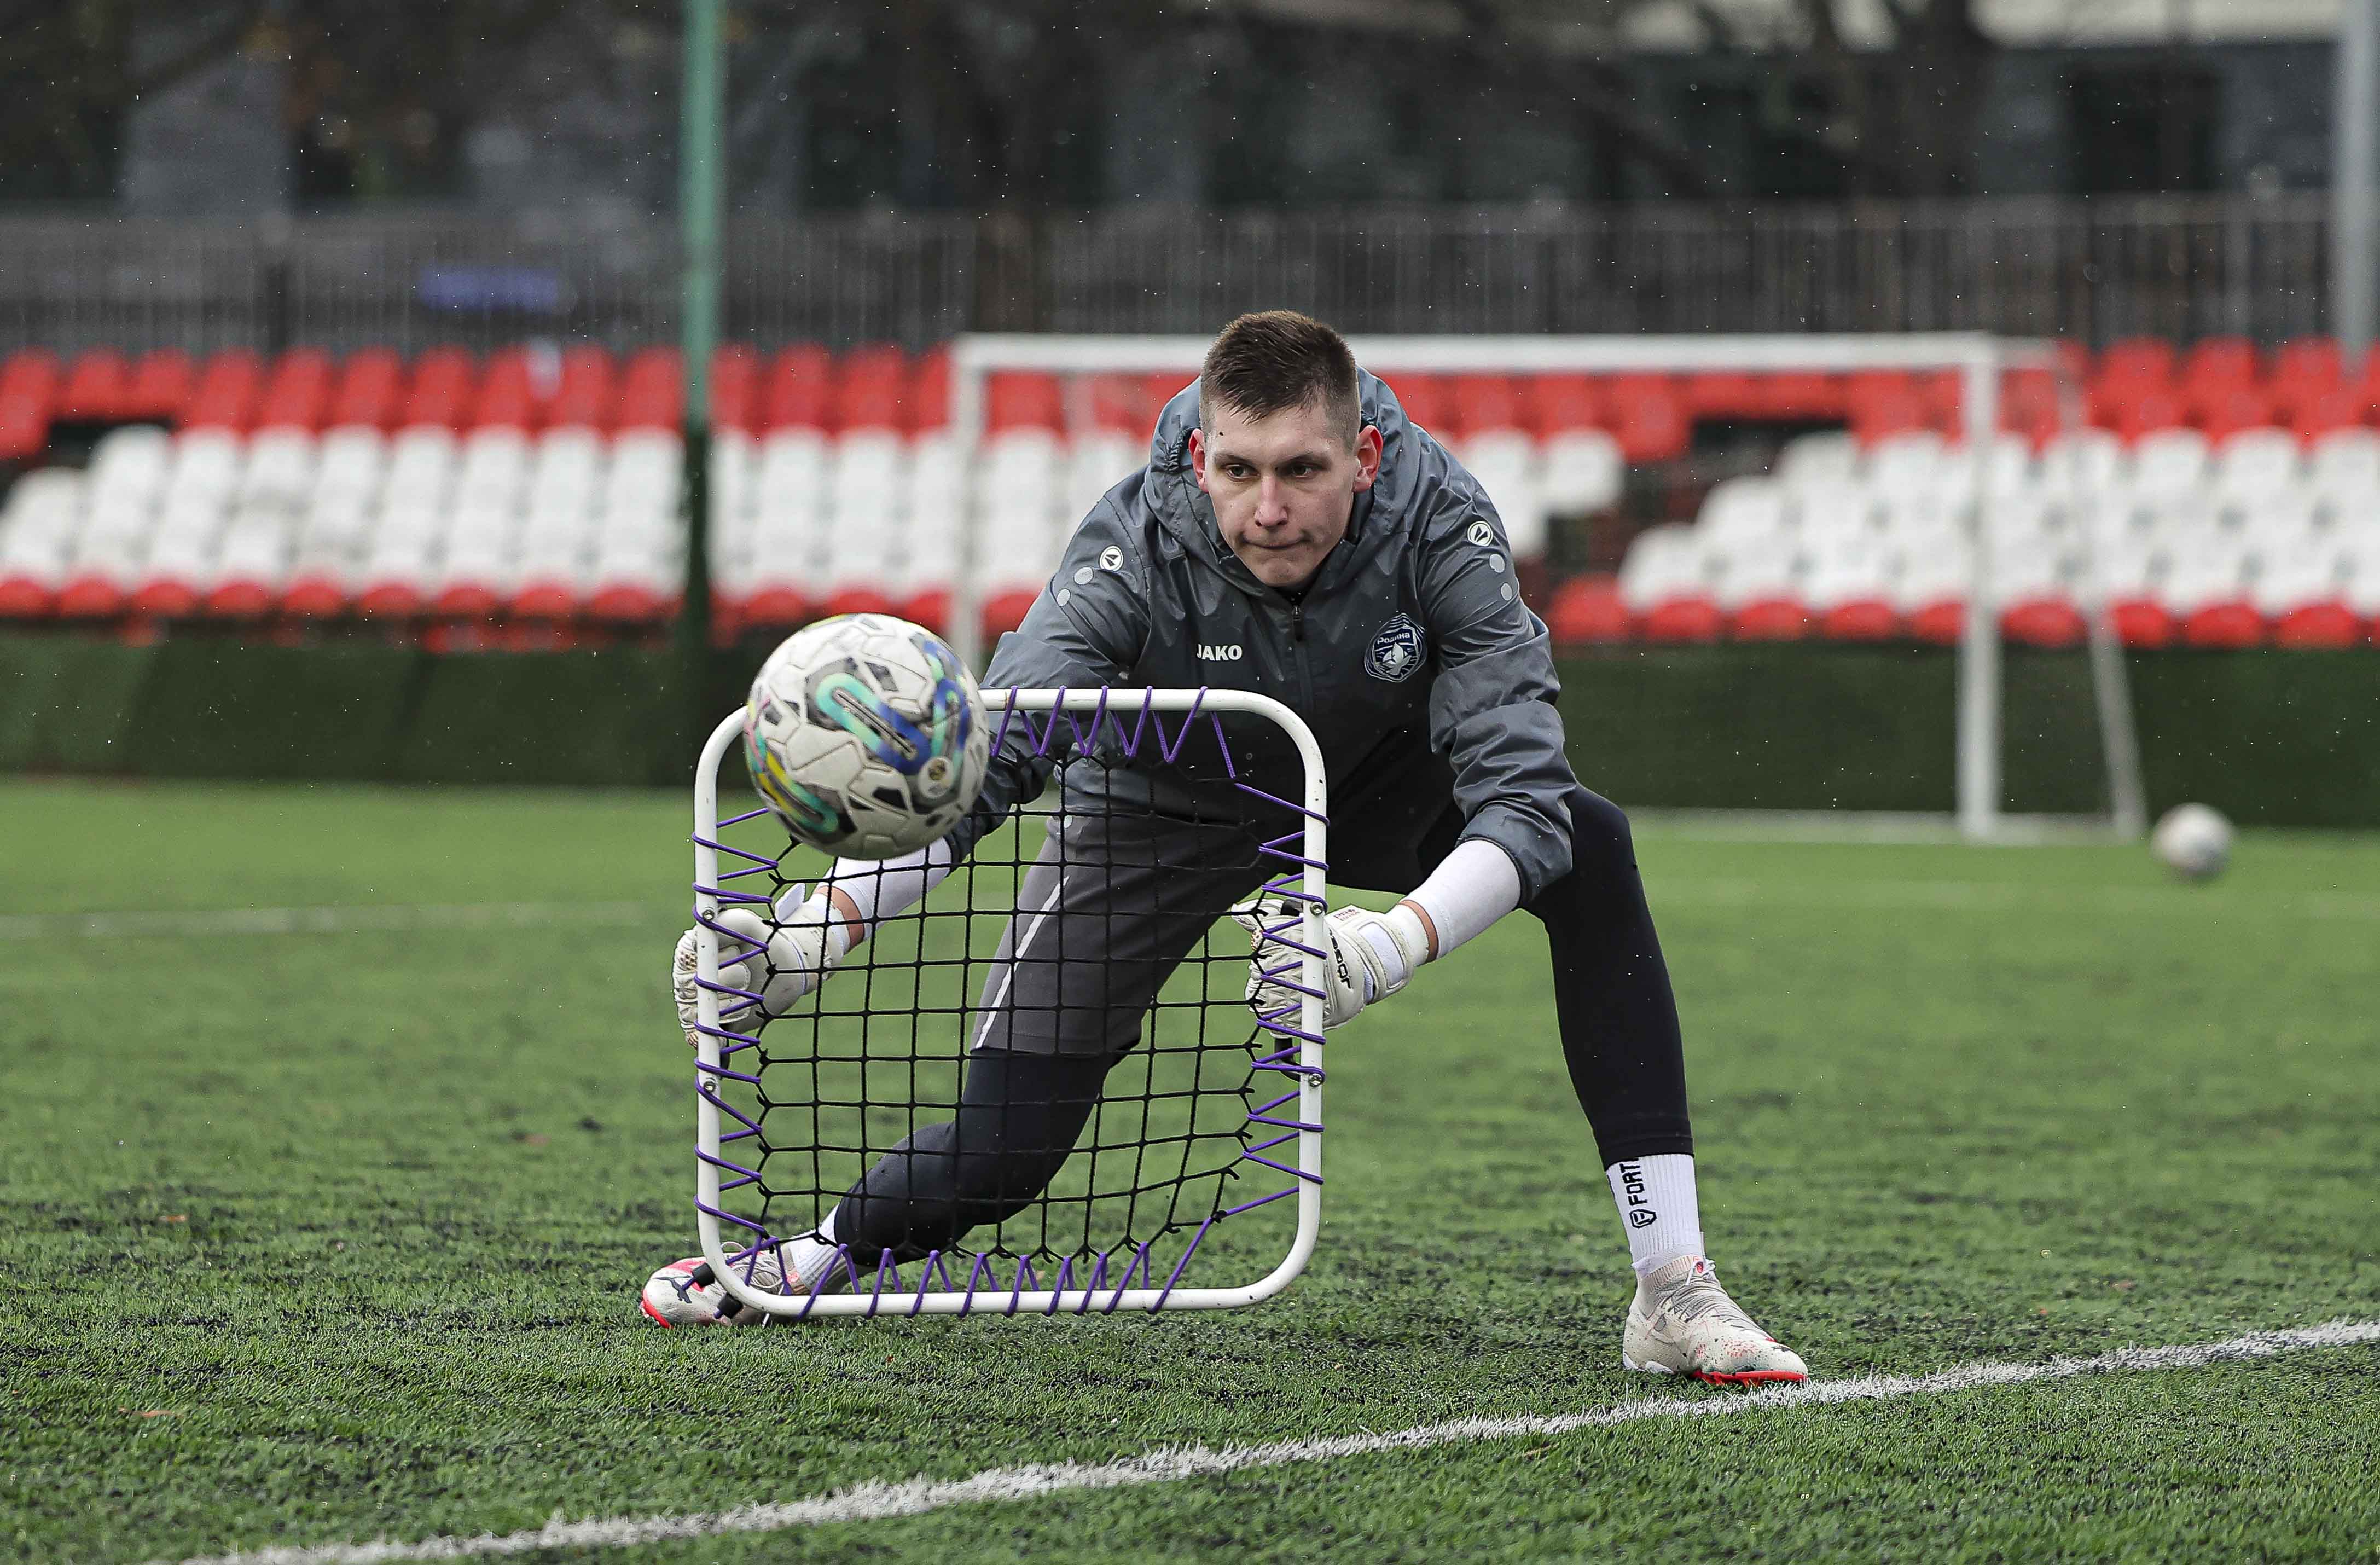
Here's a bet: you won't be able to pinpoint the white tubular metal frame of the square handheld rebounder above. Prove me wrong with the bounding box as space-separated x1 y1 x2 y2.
695 688 1331 1317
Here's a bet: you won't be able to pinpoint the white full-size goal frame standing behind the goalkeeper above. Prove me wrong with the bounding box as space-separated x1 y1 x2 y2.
950 331 2147 843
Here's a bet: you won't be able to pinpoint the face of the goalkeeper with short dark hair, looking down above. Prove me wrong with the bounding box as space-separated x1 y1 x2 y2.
1190 400 1380 588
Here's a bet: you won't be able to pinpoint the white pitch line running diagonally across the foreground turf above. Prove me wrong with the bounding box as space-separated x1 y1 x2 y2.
167 1320 2380 1565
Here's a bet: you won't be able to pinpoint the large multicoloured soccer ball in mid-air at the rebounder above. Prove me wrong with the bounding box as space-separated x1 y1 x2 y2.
745 615 990 857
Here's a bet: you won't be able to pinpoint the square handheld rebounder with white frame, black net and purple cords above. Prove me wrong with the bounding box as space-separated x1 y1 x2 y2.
693 688 1328 1320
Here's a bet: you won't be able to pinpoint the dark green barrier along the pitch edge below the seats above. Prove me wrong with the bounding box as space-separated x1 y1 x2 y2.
0 634 2380 827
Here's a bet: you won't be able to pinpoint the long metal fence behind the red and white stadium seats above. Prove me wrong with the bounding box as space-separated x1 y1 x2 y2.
0 195 2327 350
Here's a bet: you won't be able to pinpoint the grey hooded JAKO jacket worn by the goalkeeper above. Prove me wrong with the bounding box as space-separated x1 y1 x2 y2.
954 374 1576 900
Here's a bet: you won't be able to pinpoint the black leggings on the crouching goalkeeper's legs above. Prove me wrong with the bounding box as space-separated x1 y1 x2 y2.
835 789 1694 1267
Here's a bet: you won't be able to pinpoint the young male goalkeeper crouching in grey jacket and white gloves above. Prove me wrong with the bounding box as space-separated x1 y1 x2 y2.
643 310 1804 1384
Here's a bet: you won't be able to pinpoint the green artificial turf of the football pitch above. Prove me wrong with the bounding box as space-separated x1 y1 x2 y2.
0 784 2380 1560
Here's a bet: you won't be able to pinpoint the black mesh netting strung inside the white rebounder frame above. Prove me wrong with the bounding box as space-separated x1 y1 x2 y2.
712 693 1304 1291
